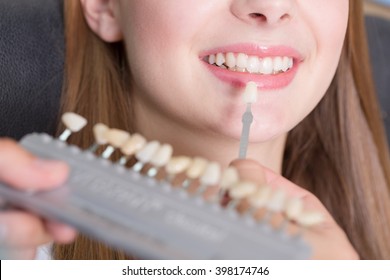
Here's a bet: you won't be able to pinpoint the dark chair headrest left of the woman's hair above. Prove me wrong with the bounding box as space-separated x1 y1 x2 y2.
0 0 64 139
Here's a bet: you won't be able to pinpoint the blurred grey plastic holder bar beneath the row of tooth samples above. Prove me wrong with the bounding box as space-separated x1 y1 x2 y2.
4 134 310 259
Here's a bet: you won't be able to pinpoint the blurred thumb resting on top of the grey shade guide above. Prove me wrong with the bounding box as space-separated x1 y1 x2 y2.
0 139 68 189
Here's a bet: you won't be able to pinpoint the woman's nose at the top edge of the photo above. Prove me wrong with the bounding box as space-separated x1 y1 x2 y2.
231 0 295 25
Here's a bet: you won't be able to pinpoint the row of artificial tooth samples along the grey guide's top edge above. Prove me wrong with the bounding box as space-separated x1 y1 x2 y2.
60 113 323 227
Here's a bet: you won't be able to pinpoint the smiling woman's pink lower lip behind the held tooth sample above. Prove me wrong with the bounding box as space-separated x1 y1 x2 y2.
204 62 298 90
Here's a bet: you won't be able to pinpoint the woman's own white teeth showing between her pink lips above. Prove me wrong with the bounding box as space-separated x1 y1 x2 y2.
208 52 294 75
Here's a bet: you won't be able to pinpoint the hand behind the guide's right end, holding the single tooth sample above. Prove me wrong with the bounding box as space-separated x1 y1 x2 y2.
231 159 359 260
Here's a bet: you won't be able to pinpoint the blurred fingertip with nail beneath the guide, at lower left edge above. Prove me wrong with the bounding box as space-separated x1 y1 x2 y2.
0 211 52 249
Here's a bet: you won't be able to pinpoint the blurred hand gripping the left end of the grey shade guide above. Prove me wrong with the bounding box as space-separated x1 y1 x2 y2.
0 139 76 259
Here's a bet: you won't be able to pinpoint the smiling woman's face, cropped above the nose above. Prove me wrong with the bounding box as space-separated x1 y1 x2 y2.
114 0 349 142
